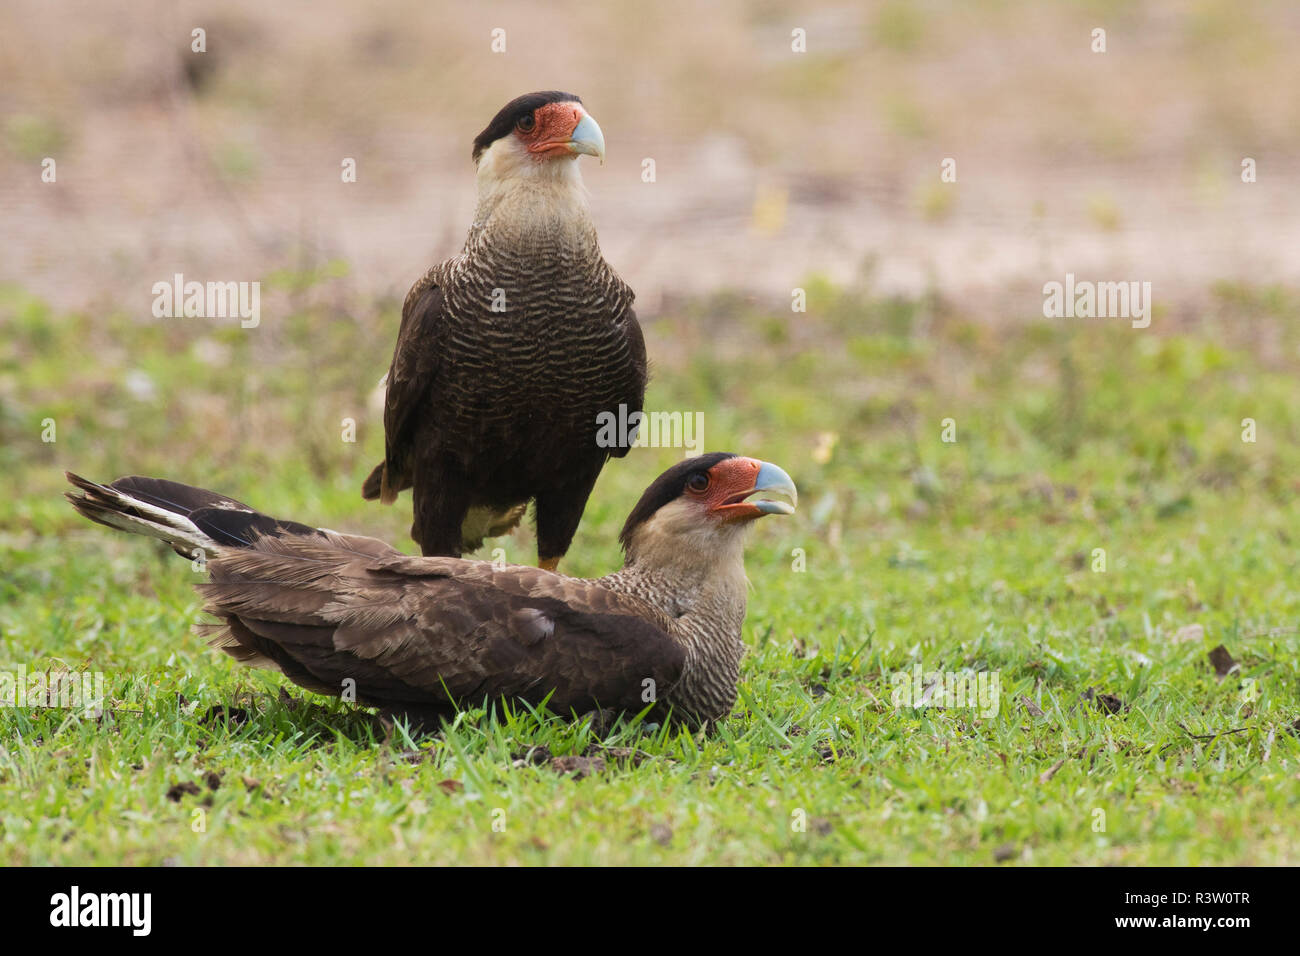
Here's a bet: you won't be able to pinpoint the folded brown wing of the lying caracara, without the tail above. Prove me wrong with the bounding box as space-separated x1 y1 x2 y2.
200 538 684 713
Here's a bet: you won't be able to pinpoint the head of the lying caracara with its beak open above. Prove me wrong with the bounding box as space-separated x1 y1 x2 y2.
619 451 798 563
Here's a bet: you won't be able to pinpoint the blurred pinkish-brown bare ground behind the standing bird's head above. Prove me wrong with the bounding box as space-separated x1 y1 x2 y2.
0 0 1300 317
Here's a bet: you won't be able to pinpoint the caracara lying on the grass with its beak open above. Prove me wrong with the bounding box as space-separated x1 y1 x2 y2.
68 453 797 726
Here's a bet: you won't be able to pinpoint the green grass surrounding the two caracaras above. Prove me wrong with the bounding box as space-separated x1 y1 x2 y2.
0 277 1300 865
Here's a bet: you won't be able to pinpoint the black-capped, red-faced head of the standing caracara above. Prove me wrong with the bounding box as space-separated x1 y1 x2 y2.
473 90 605 178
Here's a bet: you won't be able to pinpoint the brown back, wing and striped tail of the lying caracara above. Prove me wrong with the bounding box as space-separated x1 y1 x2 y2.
69 476 684 713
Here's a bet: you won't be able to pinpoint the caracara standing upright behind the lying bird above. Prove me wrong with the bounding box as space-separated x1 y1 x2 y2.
361 91 646 570
